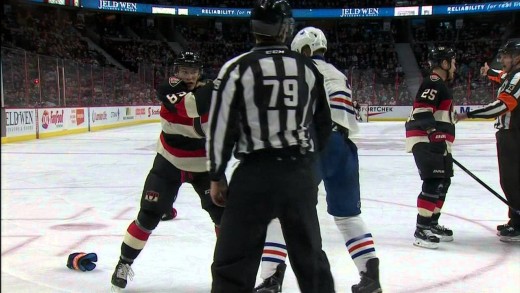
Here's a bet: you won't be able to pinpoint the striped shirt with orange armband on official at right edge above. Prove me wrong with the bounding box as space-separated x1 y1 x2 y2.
468 69 520 129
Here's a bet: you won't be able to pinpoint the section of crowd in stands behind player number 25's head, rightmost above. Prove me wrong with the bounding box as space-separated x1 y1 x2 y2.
412 19 513 105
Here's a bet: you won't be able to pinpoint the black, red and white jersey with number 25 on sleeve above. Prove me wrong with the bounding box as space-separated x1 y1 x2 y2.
405 73 455 152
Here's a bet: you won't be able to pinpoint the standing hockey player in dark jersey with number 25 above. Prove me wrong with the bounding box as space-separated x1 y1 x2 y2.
405 47 456 248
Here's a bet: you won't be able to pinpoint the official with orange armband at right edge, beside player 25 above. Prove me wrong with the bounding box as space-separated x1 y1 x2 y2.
457 41 520 242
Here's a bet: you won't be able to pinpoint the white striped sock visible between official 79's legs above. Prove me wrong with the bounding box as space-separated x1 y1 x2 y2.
260 219 287 280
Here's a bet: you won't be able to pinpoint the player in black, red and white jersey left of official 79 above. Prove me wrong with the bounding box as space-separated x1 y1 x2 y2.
112 52 223 289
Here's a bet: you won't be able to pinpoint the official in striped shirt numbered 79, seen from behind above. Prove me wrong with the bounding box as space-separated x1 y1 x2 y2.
207 0 334 293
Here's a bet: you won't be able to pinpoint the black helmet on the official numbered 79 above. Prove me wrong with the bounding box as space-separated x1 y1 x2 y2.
251 0 294 38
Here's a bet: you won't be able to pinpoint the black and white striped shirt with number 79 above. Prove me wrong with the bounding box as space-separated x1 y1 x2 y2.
206 45 332 180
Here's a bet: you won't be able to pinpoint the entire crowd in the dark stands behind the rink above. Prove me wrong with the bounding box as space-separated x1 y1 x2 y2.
2 0 512 107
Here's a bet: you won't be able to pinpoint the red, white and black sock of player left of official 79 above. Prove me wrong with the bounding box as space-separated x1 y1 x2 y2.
121 220 152 263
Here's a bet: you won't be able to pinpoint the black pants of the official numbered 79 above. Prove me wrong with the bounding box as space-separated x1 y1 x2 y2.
211 153 334 293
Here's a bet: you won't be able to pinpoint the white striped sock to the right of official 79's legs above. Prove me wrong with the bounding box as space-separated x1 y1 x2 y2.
334 215 376 272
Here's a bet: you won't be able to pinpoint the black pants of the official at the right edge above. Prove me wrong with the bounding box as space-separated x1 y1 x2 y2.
496 129 520 228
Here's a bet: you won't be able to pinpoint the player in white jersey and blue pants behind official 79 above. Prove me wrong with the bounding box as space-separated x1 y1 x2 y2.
254 27 382 293
